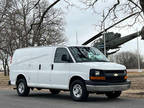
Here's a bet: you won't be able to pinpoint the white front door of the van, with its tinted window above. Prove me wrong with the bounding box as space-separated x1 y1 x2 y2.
51 48 73 89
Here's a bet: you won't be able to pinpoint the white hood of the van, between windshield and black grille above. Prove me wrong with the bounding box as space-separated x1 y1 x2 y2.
80 62 126 70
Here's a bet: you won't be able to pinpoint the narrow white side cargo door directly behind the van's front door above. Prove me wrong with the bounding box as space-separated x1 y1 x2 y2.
37 47 53 88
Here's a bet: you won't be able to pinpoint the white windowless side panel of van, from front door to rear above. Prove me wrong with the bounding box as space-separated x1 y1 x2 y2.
10 47 54 86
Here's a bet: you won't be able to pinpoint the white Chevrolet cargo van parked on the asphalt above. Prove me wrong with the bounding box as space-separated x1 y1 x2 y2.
9 46 130 101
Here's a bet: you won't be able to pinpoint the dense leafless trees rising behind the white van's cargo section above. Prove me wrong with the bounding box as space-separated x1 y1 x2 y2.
0 0 65 73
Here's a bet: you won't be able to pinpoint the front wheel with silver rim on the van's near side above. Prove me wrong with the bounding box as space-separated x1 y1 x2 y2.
70 80 89 101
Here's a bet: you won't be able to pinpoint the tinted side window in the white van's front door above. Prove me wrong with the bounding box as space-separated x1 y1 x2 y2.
54 48 72 63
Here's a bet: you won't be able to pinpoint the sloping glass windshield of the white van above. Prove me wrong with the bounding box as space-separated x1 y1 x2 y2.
69 47 109 62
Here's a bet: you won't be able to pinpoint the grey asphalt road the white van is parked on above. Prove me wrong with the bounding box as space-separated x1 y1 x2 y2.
0 90 144 108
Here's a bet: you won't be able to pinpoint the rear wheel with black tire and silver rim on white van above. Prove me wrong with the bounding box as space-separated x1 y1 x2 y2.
16 79 30 96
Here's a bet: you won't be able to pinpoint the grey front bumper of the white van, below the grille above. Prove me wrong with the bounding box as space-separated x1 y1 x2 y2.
86 80 131 92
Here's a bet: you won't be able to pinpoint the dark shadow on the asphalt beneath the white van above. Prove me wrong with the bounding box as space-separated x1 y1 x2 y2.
29 93 125 103
